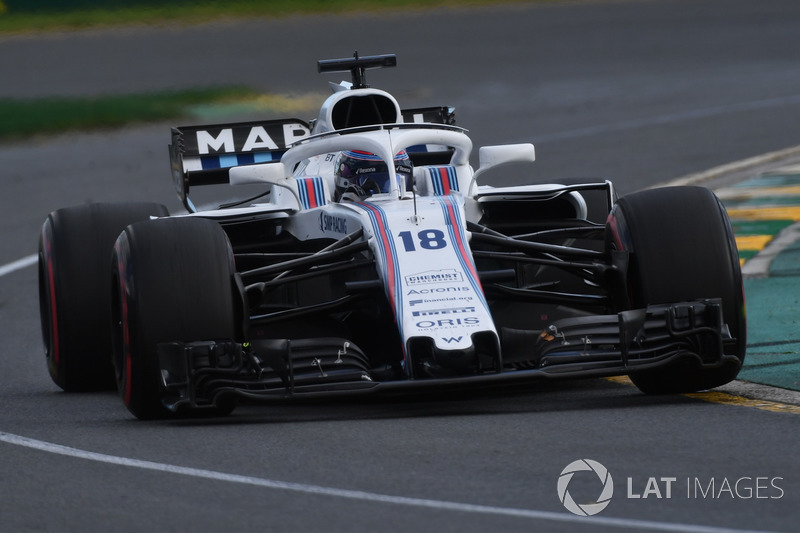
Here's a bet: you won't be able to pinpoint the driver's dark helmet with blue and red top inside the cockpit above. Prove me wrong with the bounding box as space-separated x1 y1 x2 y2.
335 150 413 202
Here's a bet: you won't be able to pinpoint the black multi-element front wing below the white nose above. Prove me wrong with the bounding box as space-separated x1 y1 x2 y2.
158 299 739 411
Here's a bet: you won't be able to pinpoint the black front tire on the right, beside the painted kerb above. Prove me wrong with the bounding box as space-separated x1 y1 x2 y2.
607 187 747 394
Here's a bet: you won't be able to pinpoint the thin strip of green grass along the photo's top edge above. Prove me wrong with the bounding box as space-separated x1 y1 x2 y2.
0 0 520 33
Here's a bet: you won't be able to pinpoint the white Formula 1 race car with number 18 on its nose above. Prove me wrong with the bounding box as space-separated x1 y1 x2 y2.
39 53 746 419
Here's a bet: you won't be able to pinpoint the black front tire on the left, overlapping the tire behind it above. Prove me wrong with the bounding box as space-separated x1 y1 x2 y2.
113 217 243 419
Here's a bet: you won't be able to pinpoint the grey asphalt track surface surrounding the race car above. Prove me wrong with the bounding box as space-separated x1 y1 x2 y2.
0 0 800 531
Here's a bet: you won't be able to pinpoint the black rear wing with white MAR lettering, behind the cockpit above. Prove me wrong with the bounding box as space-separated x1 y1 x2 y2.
169 107 455 212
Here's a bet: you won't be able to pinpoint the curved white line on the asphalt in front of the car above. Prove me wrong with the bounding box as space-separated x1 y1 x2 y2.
0 432 776 533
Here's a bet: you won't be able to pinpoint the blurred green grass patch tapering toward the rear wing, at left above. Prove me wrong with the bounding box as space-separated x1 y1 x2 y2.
0 87 257 140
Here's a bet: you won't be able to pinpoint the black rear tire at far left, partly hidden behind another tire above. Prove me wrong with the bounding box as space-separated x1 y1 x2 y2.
39 203 169 391
